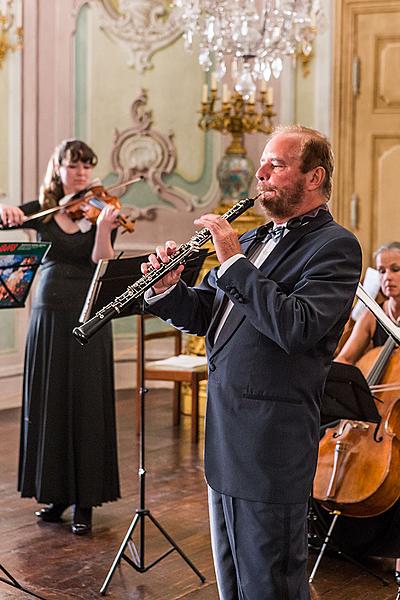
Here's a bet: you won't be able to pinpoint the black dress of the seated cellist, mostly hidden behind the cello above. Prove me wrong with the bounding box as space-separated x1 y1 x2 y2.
313 323 400 558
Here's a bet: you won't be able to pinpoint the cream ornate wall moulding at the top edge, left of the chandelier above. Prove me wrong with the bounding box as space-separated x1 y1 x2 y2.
88 0 182 73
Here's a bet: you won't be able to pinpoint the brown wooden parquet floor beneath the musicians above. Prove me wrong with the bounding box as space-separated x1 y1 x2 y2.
0 390 397 600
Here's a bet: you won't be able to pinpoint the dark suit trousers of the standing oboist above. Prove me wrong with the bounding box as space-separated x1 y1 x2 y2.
208 487 310 600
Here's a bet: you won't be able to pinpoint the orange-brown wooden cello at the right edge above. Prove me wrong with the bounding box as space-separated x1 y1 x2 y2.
313 337 400 517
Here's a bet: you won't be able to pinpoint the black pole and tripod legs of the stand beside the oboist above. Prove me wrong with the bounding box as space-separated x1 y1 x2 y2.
100 310 206 596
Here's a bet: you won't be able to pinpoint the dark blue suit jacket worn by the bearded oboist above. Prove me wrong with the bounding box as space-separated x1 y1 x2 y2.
151 212 361 503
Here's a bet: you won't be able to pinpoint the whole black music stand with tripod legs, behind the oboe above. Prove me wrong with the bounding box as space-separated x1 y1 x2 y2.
80 250 207 596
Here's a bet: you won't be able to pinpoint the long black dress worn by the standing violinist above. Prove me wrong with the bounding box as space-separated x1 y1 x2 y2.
18 202 120 506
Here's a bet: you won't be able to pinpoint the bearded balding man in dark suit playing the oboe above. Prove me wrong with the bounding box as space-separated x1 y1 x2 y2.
142 126 361 600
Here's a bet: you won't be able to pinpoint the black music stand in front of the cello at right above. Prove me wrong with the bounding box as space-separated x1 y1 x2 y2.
308 362 388 585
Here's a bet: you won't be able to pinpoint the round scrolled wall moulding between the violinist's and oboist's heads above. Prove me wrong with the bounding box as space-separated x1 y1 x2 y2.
111 90 198 220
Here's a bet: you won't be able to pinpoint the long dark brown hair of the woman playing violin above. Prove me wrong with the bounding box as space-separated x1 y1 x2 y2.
39 139 98 208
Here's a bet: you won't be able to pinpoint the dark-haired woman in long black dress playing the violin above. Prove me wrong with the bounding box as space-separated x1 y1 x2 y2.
0 140 120 534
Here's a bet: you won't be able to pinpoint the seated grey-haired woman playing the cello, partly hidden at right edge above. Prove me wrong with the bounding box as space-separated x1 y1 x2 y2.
317 242 400 585
